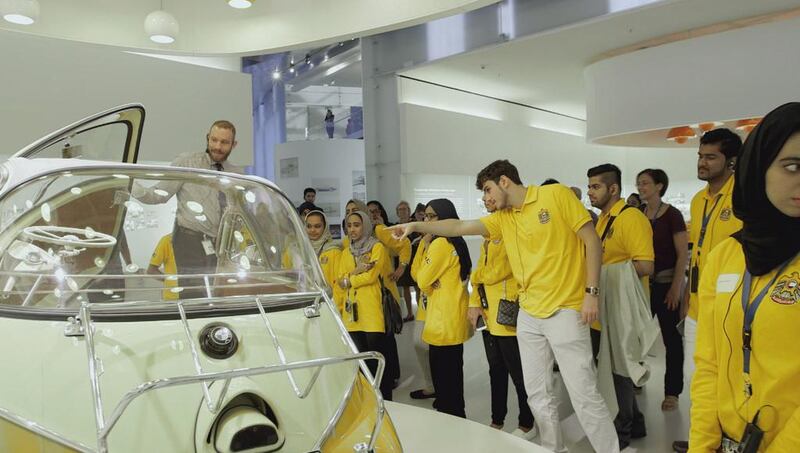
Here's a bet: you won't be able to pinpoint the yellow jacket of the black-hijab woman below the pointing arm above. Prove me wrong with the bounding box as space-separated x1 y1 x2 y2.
416 238 471 346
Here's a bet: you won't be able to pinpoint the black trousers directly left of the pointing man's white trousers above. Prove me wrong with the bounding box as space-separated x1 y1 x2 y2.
483 330 533 428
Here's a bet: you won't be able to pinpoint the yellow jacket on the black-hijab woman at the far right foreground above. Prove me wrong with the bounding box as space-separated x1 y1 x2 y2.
689 238 800 453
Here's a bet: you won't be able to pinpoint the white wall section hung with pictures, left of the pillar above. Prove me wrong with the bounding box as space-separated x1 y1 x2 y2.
275 139 366 225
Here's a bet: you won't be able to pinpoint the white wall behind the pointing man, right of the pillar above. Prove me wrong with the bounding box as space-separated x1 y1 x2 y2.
399 89 702 222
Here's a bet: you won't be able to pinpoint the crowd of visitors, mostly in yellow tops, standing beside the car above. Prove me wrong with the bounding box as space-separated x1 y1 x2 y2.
282 103 800 452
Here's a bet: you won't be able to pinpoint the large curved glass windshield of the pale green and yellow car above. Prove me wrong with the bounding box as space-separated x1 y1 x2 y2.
0 167 324 311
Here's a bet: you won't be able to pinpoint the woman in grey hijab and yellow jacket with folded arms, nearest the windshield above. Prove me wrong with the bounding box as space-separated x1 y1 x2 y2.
337 211 393 400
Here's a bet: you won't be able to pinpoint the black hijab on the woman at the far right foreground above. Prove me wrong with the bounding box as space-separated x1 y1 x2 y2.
733 102 800 275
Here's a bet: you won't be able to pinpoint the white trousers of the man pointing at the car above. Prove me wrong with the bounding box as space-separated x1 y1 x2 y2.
517 310 619 453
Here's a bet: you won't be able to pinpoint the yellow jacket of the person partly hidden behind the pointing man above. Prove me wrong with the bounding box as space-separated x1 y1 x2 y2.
469 239 519 337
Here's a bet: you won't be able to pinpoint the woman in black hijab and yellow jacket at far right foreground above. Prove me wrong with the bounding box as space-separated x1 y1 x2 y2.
689 102 800 452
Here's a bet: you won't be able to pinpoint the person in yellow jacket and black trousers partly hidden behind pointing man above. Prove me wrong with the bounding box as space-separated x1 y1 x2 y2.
468 197 537 439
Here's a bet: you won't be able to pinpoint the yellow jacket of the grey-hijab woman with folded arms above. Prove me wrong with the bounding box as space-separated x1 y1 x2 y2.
337 243 389 332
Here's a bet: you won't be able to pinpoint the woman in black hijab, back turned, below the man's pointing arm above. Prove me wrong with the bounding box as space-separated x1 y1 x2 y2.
414 198 472 418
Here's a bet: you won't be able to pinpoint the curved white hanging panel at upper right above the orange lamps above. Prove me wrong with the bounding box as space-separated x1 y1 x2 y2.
584 17 800 142
